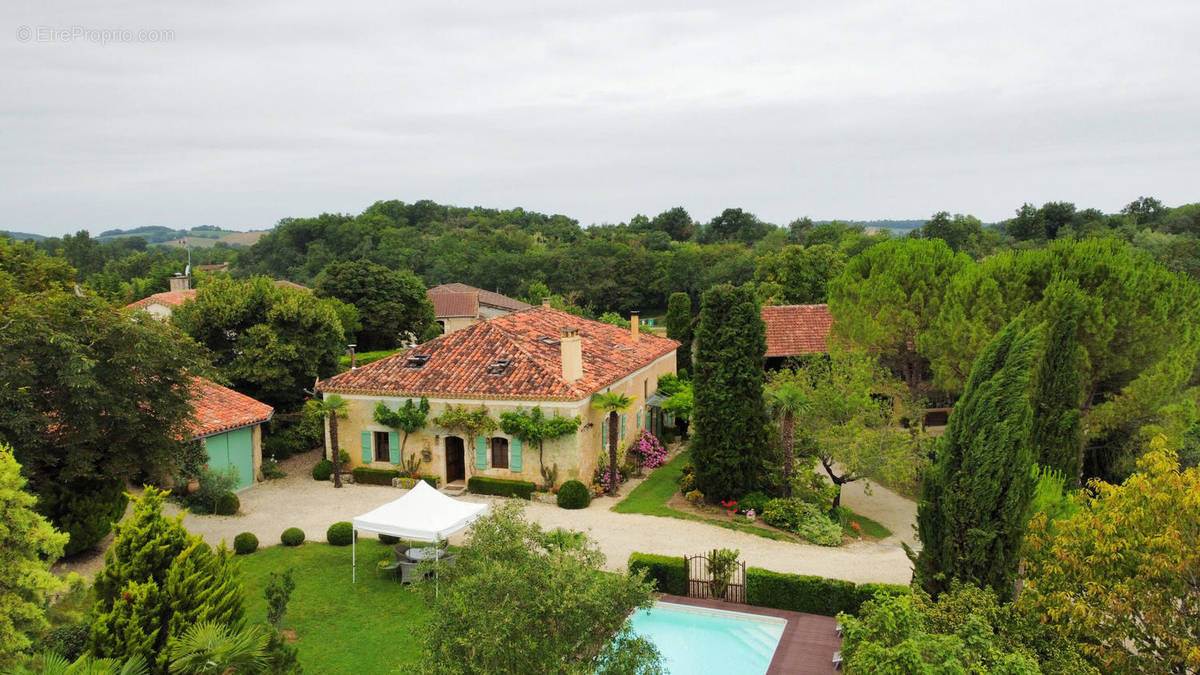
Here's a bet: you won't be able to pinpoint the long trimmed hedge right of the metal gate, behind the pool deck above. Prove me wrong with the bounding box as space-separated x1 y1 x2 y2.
739 564 912 616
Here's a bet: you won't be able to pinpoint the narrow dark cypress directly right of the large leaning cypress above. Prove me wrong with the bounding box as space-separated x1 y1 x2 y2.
1030 281 1084 482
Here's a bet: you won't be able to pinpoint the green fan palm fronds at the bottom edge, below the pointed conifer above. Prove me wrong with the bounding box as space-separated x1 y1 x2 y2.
170 621 268 675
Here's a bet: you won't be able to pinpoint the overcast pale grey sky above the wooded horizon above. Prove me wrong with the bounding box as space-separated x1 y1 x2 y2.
0 0 1200 234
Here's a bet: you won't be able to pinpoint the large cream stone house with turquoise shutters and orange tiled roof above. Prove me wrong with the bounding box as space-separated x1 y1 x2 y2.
317 306 679 484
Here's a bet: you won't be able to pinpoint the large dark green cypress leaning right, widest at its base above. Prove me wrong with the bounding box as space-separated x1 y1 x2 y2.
908 319 1037 597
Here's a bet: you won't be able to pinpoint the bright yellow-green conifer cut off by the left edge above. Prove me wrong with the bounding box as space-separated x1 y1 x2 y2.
0 443 67 667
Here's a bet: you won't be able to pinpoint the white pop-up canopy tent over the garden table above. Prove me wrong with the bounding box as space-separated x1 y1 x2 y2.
350 480 487 581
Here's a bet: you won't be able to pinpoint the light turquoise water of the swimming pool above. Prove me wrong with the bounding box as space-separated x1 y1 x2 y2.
630 603 787 675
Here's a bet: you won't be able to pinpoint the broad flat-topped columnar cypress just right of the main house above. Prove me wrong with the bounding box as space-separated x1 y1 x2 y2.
691 283 768 500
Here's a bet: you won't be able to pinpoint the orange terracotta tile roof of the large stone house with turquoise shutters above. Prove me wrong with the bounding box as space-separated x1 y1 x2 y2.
317 305 679 401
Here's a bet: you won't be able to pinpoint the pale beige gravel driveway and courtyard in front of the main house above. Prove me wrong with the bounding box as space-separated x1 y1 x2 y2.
60 453 916 584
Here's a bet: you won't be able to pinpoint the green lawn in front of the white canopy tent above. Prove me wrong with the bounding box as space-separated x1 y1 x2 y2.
239 538 428 675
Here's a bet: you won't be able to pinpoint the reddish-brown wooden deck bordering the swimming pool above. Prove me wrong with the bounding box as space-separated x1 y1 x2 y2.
659 595 841 675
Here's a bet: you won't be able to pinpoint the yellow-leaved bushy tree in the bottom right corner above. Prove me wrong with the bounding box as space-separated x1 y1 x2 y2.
1018 436 1200 673
